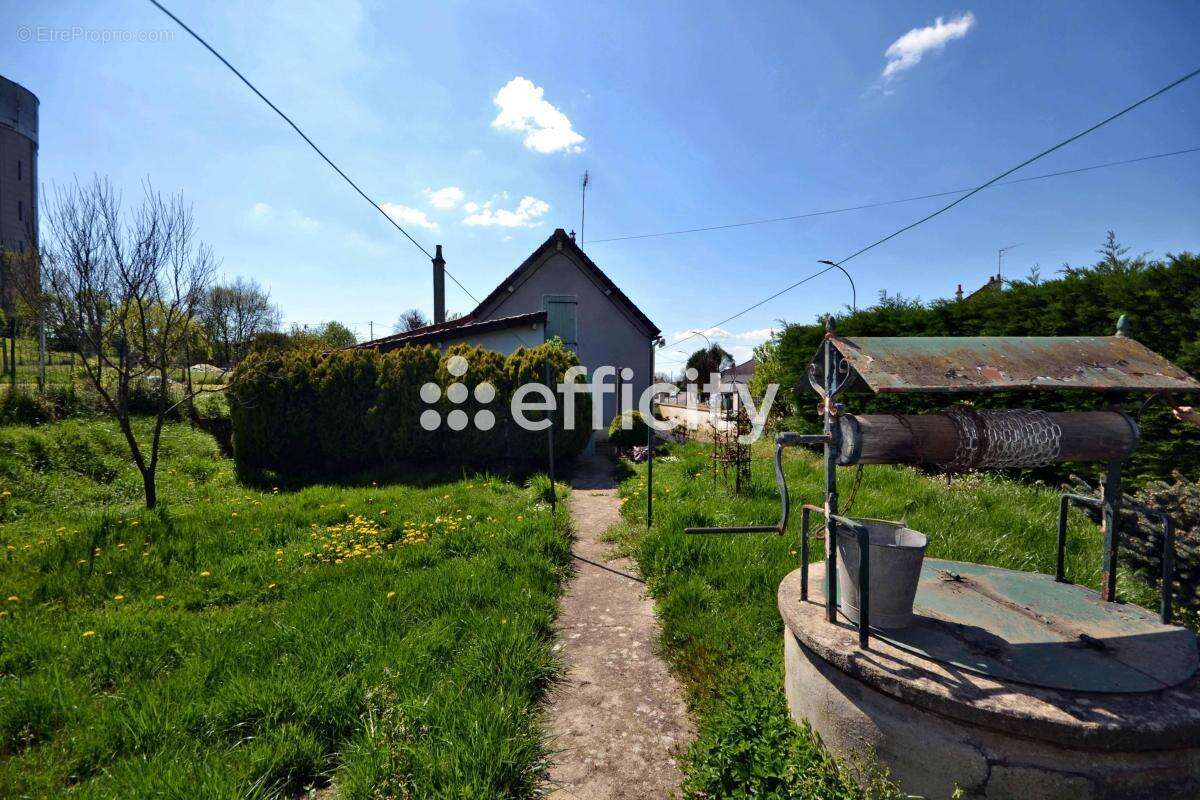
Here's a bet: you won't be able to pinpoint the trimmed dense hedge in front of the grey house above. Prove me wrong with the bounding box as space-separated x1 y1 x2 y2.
228 341 592 475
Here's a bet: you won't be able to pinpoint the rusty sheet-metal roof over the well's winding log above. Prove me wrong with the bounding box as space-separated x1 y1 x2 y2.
815 336 1200 392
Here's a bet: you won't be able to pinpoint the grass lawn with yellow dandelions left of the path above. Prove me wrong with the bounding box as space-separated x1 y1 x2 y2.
0 420 569 800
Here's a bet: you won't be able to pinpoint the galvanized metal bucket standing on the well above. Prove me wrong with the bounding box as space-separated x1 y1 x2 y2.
838 519 929 627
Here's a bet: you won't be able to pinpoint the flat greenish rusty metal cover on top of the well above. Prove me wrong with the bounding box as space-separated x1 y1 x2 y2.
875 559 1198 693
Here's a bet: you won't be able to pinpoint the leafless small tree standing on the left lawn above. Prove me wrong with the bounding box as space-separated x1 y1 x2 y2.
41 178 216 509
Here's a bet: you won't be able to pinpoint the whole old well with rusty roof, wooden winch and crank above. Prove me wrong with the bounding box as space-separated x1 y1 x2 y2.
689 321 1200 800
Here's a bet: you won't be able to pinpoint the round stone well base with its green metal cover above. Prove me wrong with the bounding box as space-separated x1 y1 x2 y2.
779 559 1200 800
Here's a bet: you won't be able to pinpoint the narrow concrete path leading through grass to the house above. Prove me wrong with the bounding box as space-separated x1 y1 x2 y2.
548 452 694 800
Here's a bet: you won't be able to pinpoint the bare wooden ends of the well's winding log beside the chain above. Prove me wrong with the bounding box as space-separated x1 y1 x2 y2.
838 411 1139 467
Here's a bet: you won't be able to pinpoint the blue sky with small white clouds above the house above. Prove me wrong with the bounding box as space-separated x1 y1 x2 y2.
0 0 1200 368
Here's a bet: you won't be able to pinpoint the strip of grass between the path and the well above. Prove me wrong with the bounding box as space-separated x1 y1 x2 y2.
617 438 1157 800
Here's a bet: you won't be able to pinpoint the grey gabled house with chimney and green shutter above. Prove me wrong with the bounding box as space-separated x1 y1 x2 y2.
358 228 661 429
